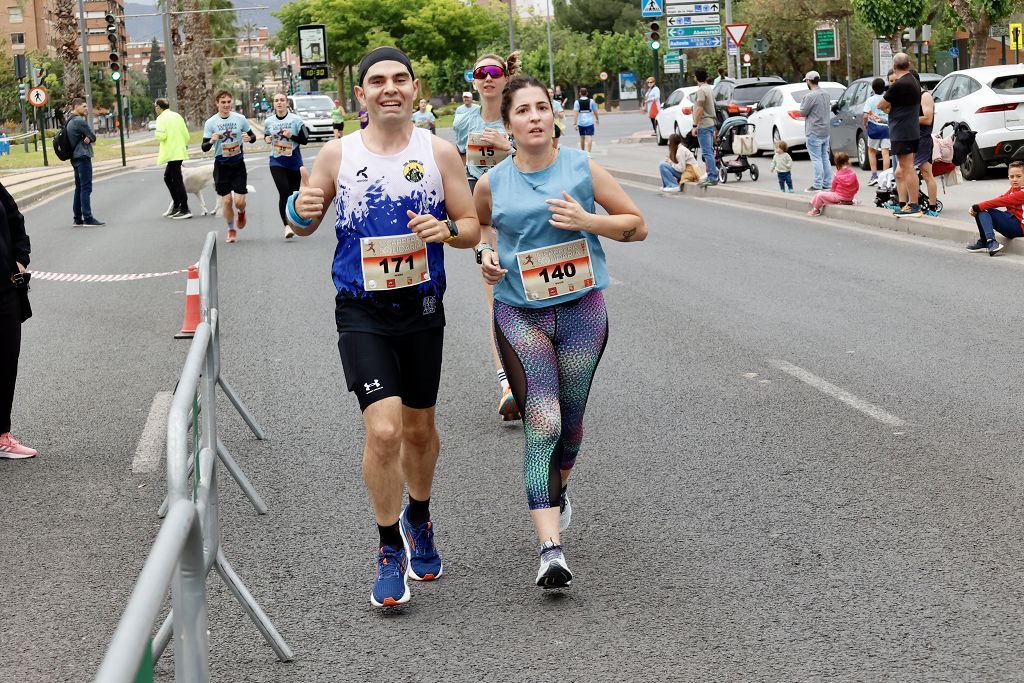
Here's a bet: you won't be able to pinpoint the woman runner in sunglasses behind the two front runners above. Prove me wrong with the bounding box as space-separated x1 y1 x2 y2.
454 52 520 422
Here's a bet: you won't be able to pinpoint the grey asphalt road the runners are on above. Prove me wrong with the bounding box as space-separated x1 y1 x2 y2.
0 143 1024 682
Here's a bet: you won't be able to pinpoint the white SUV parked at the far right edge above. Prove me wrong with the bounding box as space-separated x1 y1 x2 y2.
932 65 1024 180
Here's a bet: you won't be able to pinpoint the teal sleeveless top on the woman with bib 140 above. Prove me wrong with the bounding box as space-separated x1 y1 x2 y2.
487 147 608 308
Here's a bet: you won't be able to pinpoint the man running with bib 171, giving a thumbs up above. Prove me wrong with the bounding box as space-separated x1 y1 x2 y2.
288 47 480 607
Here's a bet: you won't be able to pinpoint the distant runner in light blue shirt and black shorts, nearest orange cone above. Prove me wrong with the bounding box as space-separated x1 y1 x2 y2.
203 90 256 242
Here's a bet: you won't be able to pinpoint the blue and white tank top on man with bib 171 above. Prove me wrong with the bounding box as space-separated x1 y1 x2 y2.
331 128 447 304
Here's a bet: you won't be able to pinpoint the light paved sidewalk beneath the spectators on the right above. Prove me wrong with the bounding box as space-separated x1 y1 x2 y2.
594 133 1024 255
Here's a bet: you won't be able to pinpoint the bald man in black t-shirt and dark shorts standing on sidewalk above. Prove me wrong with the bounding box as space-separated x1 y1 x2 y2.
879 52 924 216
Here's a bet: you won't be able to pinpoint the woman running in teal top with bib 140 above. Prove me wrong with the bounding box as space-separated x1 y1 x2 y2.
474 76 647 588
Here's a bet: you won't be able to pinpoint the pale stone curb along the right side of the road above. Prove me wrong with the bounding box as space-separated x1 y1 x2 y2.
605 167 1024 255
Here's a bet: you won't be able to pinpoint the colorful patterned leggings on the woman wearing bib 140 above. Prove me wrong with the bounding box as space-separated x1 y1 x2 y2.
495 290 608 510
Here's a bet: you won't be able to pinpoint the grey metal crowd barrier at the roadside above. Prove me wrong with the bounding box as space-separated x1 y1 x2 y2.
96 232 293 683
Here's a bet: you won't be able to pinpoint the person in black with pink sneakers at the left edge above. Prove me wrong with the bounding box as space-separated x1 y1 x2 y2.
0 184 38 460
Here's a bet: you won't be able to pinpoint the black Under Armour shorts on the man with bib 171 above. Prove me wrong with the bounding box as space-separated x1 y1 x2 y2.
338 328 444 411
